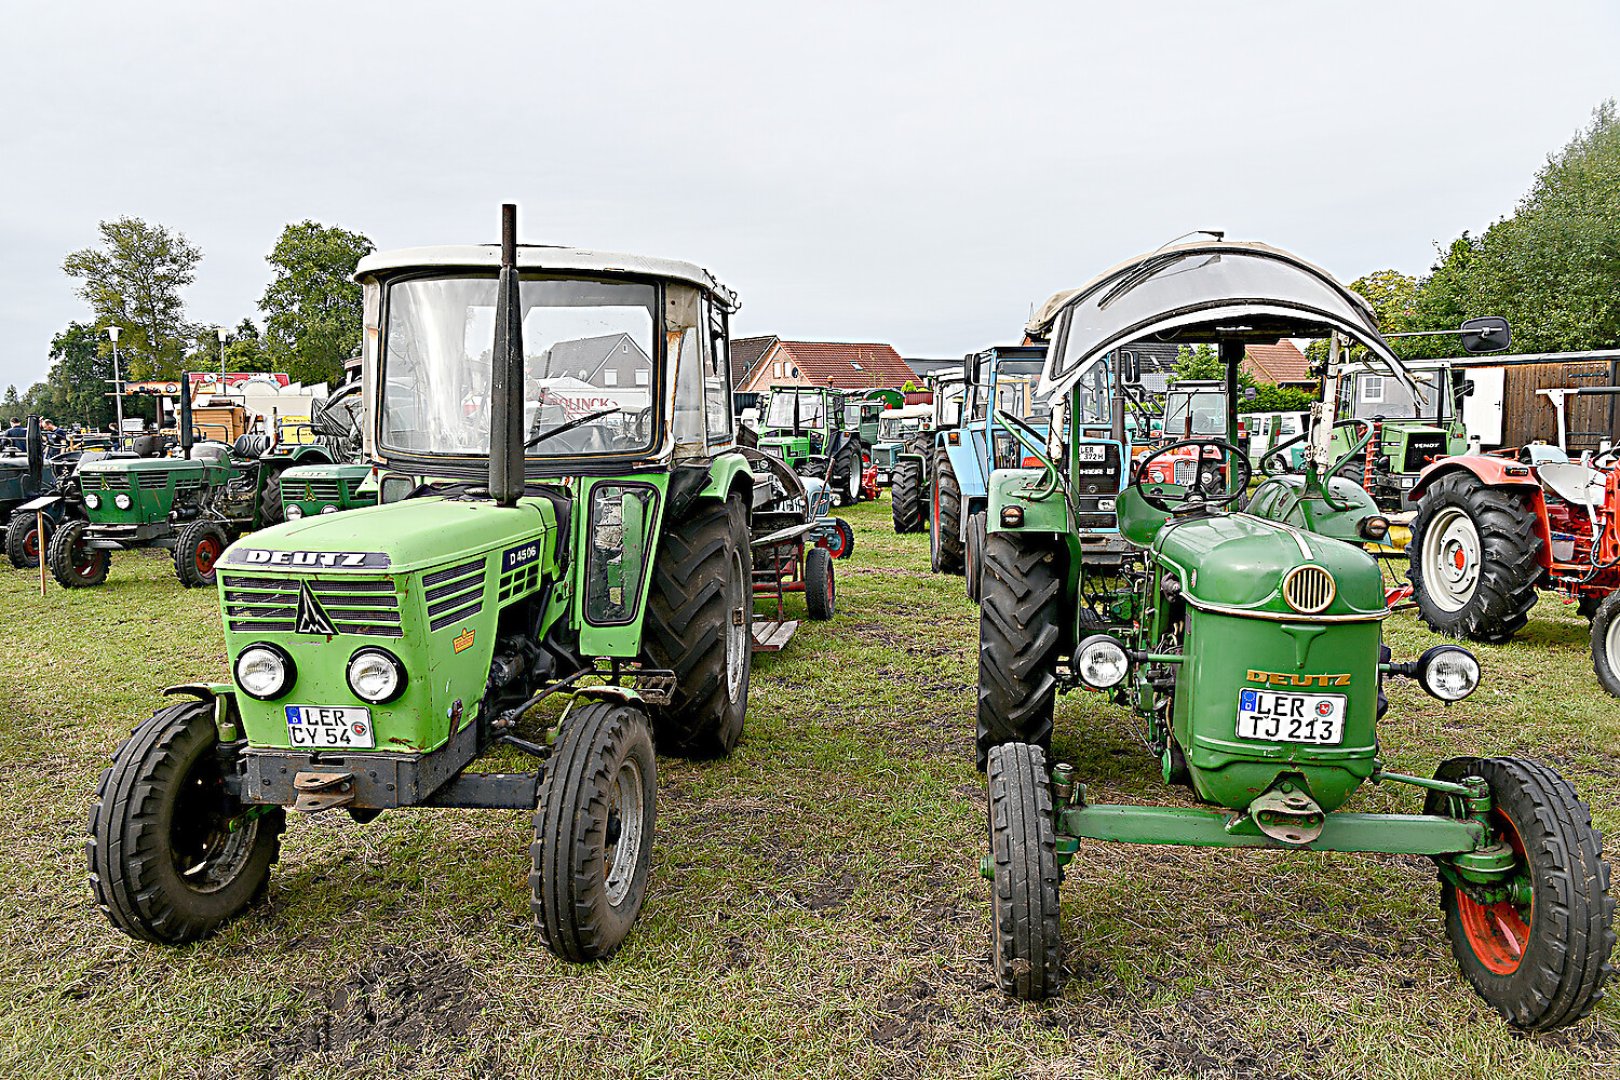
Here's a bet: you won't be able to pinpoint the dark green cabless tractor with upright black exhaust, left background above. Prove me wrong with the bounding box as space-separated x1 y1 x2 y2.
45 379 332 589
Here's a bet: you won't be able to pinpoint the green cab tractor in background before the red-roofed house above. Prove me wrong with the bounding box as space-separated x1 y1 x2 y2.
758 385 883 507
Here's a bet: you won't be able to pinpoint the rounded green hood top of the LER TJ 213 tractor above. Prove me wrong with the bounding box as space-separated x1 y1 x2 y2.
1155 513 1388 620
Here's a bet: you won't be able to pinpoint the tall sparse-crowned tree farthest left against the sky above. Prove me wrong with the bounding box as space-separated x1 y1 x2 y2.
62 217 203 379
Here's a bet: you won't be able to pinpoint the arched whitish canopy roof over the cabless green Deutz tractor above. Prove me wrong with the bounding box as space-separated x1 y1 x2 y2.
1024 241 1416 397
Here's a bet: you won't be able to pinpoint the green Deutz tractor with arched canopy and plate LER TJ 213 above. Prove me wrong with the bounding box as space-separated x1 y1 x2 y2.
978 243 1615 1030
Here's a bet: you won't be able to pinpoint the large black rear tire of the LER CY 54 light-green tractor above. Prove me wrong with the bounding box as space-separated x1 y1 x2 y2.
642 499 753 758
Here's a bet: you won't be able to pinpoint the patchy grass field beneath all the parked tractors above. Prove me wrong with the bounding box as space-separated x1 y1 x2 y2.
0 500 1620 1080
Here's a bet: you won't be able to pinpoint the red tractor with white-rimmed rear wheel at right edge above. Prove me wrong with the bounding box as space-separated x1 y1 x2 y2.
1406 445 1620 698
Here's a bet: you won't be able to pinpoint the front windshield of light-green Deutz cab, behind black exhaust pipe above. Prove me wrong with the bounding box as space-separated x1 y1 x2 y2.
381 275 658 457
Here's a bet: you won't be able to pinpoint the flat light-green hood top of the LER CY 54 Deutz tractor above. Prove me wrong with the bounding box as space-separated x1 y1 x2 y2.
220 499 556 573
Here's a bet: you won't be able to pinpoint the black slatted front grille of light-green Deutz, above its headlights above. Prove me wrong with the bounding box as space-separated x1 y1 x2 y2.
220 573 405 638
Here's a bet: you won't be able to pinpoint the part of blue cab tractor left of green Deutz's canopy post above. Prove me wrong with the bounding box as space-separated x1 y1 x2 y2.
930 345 1048 601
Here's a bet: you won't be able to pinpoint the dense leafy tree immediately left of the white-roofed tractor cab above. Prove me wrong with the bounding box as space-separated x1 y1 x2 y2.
259 222 374 382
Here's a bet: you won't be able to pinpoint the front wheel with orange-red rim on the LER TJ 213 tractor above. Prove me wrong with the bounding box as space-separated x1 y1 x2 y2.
1427 758 1615 1031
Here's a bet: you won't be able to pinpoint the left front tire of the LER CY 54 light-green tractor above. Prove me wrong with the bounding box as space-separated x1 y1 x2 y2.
84 701 287 946
